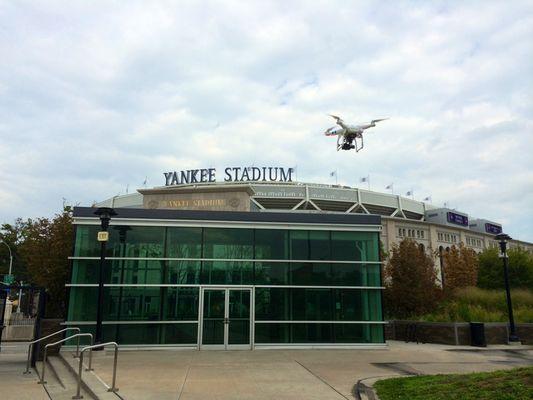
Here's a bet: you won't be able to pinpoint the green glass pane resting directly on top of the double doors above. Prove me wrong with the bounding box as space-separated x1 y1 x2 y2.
201 261 253 285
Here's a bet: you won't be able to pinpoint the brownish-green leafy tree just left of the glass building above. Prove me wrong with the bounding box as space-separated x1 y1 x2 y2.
20 206 73 317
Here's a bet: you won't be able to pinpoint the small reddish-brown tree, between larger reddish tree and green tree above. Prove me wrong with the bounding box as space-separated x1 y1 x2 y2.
442 243 478 291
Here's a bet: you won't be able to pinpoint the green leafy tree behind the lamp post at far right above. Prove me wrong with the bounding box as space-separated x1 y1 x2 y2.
477 247 533 290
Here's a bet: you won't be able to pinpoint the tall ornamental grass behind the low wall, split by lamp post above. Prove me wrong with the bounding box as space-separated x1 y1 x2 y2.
418 287 533 322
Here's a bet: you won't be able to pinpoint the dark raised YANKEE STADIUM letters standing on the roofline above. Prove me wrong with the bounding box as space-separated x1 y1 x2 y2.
163 167 294 186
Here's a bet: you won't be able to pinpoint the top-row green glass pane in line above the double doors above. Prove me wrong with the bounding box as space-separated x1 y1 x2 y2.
204 228 253 259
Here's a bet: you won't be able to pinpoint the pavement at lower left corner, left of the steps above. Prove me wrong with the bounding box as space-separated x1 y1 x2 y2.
0 342 49 400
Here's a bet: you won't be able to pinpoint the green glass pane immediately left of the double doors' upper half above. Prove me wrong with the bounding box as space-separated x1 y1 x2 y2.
163 287 199 321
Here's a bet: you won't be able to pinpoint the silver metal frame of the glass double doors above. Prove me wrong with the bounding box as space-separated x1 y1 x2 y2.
198 285 255 350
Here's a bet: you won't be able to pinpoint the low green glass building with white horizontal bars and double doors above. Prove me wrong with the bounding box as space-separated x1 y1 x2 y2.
65 207 384 349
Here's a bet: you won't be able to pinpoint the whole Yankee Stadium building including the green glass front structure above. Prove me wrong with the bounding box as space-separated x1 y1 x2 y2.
65 170 533 349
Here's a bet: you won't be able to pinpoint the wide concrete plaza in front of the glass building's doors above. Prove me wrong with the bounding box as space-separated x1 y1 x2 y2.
85 342 533 400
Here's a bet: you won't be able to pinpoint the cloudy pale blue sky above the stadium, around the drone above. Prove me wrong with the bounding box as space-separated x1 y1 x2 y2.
0 0 533 241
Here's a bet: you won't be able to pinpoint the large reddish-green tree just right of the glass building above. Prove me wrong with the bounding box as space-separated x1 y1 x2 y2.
384 239 441 318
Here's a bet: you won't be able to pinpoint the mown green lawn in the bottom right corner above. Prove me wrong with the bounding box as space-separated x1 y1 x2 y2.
374 367 533 400
